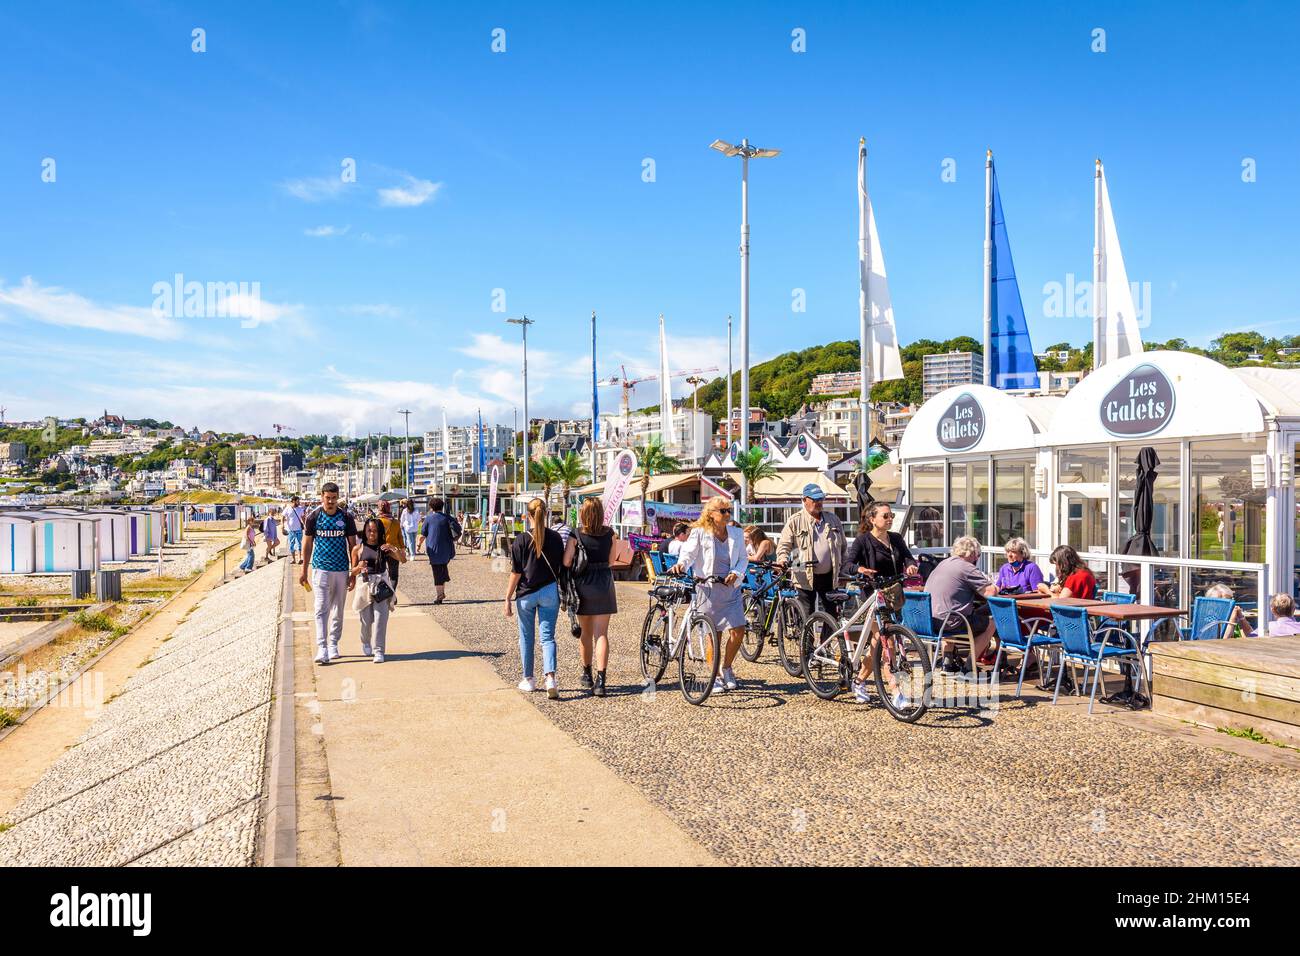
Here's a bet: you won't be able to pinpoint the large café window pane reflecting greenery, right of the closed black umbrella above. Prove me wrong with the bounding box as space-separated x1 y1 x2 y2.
1192 436 1268 562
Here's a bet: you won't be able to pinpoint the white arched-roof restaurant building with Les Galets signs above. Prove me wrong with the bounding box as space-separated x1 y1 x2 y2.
898 351 1300 623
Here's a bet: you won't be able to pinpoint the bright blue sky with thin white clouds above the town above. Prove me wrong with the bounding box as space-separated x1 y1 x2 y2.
0 3 1300 433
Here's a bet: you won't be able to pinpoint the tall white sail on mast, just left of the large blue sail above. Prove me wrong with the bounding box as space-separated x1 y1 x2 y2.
858 138 902 460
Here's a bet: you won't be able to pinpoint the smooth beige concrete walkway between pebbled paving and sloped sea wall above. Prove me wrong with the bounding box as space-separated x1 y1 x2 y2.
294 580 716 866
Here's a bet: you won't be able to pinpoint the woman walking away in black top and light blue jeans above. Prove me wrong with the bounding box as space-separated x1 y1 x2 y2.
506 498 564 700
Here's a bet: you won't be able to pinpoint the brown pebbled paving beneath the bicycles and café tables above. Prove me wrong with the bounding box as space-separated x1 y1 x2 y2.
400 555 1300 865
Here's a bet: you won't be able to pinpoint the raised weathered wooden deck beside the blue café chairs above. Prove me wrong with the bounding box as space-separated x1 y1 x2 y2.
1151 637 1300 747
